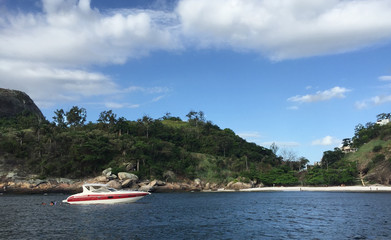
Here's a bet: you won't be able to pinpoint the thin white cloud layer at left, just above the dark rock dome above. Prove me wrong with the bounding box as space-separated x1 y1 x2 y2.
0 59 117 107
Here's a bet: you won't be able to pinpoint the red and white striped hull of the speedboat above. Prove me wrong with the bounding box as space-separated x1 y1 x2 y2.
64 192 150 205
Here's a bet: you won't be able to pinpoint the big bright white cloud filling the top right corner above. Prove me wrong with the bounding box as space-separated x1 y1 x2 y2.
176 0 391 60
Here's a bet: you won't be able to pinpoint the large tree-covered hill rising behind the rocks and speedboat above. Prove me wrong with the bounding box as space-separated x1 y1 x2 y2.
0 106 288 182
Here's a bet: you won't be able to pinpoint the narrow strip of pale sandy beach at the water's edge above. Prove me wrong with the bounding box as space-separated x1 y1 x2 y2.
239 185 391 192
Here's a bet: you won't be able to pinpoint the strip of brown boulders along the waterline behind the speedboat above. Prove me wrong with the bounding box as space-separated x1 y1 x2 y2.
0 169 253 193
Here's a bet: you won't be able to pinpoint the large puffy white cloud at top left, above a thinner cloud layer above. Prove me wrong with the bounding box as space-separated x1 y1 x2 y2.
0 0 180 66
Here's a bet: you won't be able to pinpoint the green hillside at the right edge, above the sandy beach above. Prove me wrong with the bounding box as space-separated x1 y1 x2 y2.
307 113 391 185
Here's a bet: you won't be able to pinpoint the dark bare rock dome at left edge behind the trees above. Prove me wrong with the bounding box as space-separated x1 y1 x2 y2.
0 88 44 120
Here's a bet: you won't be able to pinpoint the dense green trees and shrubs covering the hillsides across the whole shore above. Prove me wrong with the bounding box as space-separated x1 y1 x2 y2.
0 106 391 186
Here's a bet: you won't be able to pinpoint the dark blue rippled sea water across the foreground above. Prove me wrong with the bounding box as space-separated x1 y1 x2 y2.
0 192 391 239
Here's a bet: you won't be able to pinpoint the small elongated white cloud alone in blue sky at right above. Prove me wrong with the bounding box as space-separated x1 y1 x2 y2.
288 86 350 103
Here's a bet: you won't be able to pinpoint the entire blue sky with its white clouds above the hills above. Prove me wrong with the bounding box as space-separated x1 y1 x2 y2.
0 0 391 162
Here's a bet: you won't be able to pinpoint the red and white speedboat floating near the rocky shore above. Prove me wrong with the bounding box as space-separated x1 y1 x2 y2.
63 183 151 204
